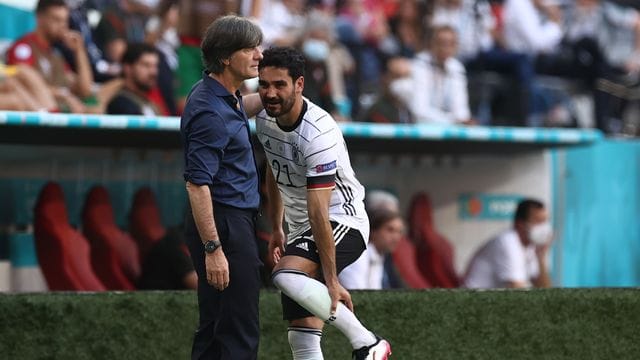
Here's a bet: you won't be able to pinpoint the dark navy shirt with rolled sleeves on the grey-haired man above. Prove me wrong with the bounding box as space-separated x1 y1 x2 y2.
180 74 260 209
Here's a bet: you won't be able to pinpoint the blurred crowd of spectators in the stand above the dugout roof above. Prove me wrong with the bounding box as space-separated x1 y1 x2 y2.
0 0 640 136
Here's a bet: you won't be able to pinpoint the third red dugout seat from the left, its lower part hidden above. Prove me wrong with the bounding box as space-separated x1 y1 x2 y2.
129 187 167 264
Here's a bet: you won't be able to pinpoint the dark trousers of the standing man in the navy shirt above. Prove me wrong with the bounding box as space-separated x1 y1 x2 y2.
185 204 262 360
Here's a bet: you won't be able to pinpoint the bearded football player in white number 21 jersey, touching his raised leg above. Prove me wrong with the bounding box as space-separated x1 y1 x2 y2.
256 47 391 360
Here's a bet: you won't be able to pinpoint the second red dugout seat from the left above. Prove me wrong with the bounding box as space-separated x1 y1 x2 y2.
82 186 140 290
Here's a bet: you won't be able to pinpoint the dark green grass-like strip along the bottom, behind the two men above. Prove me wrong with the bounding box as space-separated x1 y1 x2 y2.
0 289 640 360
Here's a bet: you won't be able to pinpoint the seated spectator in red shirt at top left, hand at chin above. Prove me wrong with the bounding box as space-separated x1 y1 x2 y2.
7 0 93 105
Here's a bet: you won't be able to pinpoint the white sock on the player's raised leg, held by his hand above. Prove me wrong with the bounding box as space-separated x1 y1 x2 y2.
273 270 376 349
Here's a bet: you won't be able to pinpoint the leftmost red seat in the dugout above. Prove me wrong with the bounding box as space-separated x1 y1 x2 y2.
34 182 106 291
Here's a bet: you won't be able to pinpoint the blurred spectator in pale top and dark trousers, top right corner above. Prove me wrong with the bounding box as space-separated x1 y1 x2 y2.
560 0 640 133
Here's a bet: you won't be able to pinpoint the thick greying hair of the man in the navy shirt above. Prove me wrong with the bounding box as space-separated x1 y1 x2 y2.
200 15 262 74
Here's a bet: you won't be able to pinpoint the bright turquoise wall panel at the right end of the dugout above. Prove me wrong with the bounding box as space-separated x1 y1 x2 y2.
552 140 640 287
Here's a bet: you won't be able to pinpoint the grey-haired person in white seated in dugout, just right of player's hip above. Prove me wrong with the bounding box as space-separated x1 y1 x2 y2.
339 208 404 290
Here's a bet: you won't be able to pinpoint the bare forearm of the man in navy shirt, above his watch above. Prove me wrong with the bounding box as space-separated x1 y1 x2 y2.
187 181 218 242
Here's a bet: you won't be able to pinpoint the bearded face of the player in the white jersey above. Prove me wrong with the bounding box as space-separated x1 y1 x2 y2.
258 66 304 117
